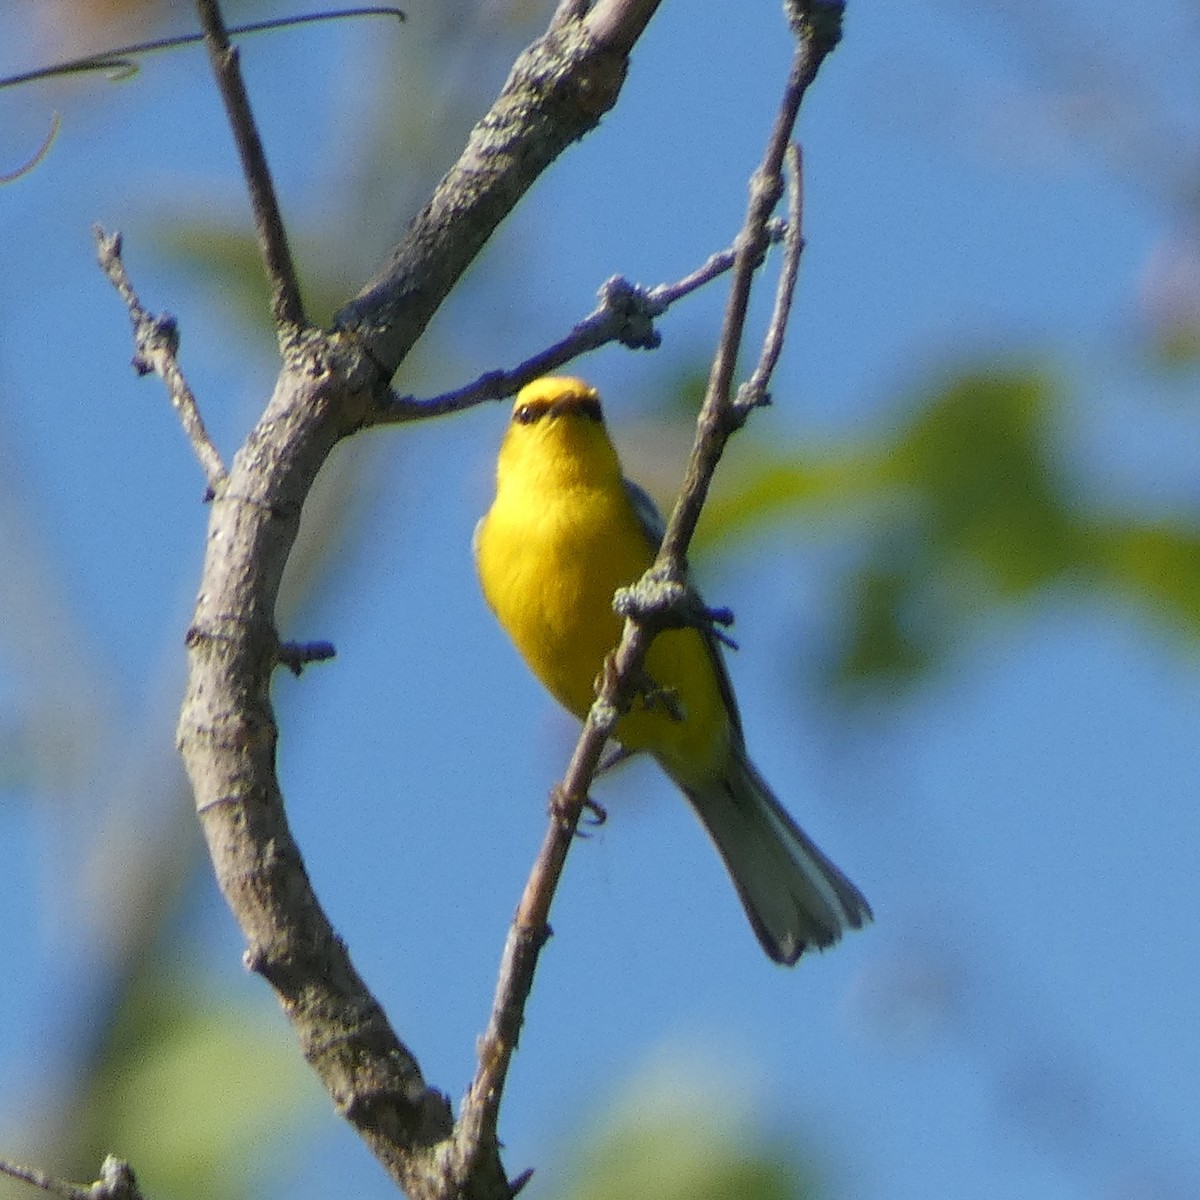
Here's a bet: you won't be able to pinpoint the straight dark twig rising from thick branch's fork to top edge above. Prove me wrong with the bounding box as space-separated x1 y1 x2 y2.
196 0 305 331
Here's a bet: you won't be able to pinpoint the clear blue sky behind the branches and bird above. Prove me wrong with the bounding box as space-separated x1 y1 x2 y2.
0 0 1200 1200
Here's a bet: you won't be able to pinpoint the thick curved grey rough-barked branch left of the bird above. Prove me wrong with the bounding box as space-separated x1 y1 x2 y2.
171 0 654 1200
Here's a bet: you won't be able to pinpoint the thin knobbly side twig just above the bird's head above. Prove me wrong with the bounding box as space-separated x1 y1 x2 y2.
368 221 788 425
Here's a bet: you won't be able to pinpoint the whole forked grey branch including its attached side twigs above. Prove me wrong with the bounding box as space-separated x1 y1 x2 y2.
93 0 840 1200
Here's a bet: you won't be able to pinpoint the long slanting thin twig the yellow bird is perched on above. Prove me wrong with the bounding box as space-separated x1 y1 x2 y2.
456 6 840 1164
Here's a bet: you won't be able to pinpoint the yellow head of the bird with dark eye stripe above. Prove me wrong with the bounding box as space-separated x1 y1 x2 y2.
497 376 620 488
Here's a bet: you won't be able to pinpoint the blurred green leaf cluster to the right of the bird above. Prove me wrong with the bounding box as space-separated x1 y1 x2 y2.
676 364 1200 696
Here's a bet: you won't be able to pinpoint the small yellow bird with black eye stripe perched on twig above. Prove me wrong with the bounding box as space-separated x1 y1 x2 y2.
474 376 872 966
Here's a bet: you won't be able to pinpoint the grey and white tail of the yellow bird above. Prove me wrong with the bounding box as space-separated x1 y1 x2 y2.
677 748 871 966
